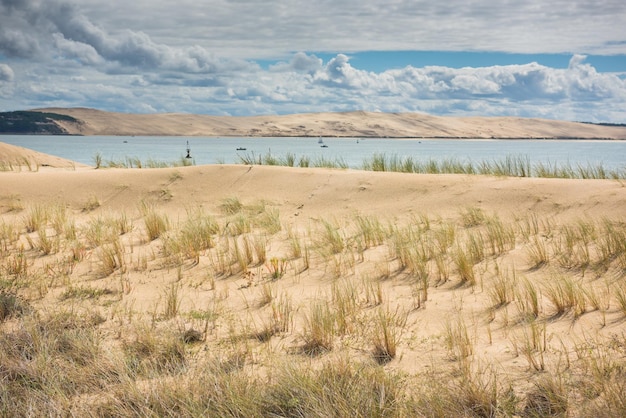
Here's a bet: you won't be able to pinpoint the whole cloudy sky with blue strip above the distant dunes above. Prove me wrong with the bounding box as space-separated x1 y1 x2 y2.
0 0 626 123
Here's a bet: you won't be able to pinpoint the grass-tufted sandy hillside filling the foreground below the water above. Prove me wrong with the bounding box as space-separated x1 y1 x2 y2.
0 145 626 416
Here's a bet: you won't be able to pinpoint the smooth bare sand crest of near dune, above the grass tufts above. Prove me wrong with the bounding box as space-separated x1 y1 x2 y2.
0 161 626 219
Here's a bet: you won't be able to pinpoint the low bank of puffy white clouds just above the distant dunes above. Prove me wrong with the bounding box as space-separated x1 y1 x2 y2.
0 48 626 122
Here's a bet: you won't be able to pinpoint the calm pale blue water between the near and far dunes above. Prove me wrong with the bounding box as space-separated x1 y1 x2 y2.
0 135 626 169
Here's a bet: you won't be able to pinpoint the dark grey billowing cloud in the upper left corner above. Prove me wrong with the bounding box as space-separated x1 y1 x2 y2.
0 0 250 73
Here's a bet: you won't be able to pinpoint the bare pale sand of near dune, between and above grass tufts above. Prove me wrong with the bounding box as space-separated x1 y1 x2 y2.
0 143 626 414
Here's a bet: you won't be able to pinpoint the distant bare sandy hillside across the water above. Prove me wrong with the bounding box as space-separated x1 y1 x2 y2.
33 108 626 139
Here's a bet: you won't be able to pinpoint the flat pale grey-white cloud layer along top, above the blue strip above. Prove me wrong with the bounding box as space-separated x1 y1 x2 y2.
73 0 626 59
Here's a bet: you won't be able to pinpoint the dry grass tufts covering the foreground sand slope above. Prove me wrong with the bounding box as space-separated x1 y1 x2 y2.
0 189 626 417
